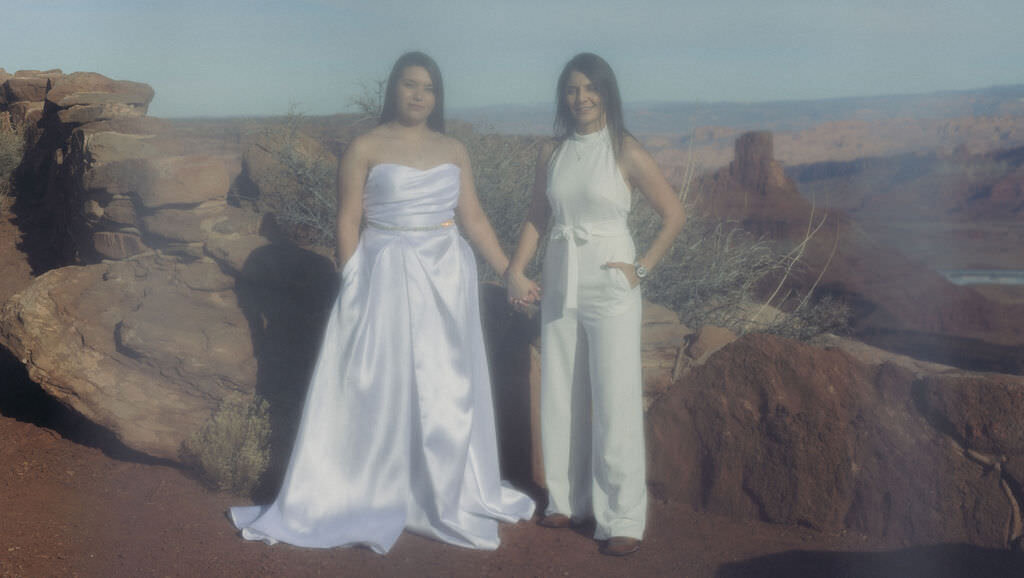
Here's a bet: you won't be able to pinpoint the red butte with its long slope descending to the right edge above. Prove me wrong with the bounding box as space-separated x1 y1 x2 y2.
694 133 1024 364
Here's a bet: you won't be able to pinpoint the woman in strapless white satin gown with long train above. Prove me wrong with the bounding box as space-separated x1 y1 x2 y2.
230 52 534 553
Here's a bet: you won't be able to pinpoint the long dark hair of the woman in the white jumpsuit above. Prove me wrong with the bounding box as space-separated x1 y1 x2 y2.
554 52 629 159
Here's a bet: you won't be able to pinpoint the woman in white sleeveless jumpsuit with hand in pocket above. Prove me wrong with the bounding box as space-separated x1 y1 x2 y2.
506 53 685 555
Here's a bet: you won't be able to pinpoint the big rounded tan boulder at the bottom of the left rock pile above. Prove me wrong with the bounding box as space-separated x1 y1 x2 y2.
0 257 257 459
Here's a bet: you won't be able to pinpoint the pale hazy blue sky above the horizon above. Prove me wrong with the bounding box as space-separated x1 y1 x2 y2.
0 0 1024 118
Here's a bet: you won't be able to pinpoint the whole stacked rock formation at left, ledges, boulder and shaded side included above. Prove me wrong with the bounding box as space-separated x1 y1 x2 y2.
0 71 335 459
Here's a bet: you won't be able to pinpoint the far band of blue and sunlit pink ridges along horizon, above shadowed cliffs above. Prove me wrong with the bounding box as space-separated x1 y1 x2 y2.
451 85 1024 171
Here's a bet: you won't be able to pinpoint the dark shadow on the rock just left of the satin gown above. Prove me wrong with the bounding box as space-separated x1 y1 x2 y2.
236 241 338 502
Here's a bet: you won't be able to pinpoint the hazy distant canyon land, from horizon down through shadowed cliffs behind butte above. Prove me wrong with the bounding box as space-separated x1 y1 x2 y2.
464 85 1024 274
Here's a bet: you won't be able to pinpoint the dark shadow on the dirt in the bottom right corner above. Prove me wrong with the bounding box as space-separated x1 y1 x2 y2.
715 544 1024 578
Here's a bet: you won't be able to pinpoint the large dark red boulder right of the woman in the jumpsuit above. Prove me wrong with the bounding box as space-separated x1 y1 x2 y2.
647 334 1024 547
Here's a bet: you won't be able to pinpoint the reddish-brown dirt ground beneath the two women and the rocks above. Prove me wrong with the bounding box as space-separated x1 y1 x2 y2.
0 204 1024 578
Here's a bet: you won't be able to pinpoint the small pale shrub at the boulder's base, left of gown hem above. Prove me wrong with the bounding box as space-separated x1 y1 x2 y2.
181 398 270 495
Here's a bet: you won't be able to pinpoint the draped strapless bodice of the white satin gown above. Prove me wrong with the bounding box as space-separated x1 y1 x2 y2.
362 163 460 228
